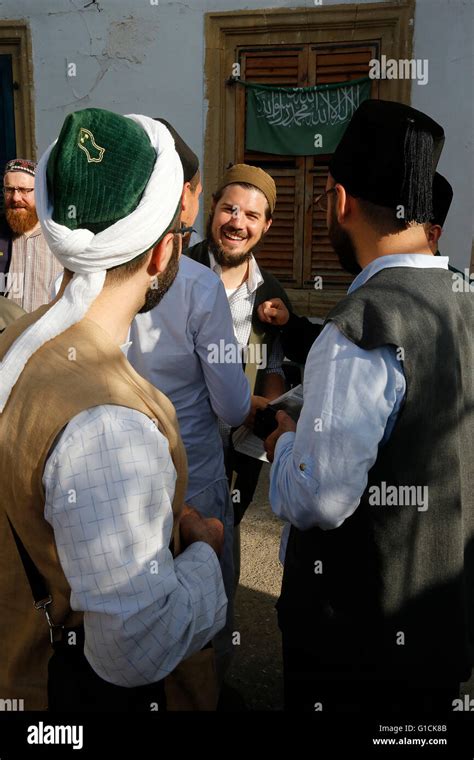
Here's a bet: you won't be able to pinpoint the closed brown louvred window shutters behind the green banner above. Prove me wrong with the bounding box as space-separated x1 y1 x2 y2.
235 42 378 302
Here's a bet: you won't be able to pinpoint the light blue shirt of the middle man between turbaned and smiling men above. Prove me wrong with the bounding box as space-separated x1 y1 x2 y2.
128 256 250 499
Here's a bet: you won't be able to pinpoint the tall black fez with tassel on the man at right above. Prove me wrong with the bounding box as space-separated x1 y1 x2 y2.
329 99 444 224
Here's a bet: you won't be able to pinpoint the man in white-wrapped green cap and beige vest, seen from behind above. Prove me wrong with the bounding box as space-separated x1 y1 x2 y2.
0 109 227 711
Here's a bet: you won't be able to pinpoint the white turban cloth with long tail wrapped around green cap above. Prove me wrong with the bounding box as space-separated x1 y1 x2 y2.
0 114 183 412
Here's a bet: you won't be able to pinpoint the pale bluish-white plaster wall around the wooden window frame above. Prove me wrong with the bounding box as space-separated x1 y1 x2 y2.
0 0 473 267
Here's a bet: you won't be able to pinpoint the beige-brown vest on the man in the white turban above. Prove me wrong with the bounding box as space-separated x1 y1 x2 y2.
0 306 187 710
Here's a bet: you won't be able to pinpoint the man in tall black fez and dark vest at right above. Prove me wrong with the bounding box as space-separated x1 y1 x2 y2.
265 100 474 717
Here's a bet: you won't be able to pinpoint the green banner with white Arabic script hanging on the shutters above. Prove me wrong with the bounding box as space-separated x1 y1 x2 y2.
246 77 372 156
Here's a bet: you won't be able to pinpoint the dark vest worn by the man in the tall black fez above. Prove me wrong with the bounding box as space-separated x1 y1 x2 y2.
277 267 474 680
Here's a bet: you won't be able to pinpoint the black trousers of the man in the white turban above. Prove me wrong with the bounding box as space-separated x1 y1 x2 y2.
48 628 166 713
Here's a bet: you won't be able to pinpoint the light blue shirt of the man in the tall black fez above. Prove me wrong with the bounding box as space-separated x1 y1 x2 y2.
270 254 448 530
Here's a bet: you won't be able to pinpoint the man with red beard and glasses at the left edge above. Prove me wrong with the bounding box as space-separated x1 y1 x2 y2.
0 158 63 312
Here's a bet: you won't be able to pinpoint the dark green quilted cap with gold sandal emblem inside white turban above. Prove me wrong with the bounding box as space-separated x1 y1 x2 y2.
47 108 156 233
